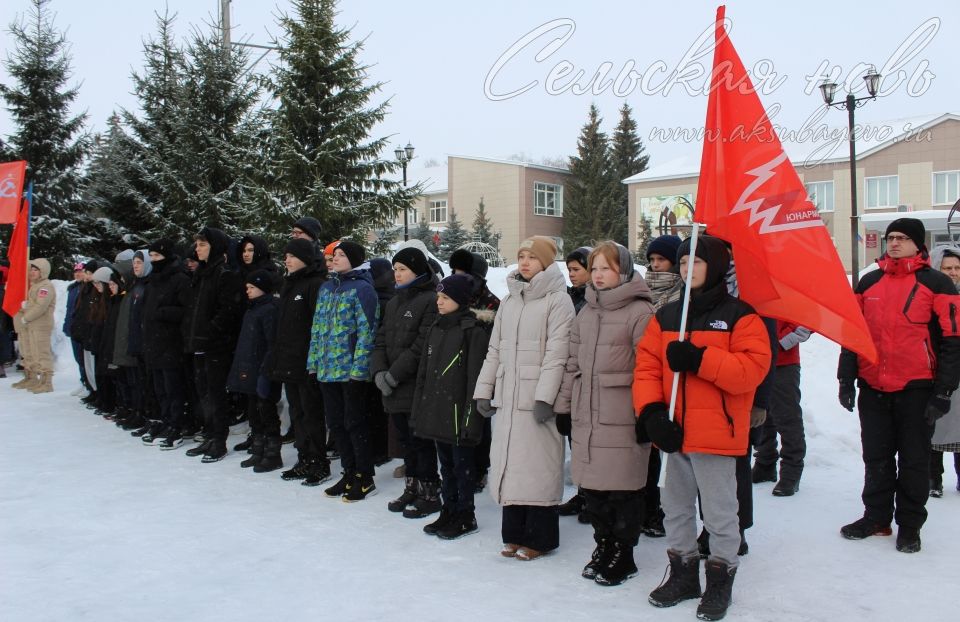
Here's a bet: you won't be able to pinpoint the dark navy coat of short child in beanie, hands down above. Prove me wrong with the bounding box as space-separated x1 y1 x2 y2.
227 294 280 398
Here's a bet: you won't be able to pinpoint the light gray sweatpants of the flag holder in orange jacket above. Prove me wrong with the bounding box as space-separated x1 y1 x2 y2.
661 452 740 568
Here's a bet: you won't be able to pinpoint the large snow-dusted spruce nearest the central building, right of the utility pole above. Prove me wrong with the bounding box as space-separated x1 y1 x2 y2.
268 0 420 240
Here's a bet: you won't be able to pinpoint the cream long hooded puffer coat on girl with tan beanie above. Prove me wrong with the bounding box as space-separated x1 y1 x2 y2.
473 263 574 506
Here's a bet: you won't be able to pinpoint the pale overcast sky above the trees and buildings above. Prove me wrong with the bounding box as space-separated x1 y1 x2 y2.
0 0 960 174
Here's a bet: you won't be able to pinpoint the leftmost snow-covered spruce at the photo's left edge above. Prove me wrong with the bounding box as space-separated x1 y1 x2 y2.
0 0 96 276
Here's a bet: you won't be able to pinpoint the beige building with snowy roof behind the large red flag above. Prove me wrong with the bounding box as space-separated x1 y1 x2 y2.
623 114 960 271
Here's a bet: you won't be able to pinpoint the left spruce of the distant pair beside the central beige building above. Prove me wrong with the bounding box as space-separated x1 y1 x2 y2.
563 104 620 248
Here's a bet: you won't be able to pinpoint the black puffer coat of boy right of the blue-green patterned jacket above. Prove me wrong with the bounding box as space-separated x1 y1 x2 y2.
370 273 437 413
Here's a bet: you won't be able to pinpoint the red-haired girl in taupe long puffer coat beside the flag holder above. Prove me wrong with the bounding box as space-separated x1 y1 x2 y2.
555 242 654 585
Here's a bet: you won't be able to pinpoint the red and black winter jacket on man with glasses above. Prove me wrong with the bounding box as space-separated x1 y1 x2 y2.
837 251 960 392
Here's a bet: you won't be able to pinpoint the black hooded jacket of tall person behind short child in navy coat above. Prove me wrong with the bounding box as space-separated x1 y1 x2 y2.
183 227 246 353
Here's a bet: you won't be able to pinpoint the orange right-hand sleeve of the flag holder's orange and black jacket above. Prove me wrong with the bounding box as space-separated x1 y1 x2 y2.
697 313 771 395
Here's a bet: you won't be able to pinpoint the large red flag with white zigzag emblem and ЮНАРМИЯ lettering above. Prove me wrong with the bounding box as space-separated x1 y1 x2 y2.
695 6 877 361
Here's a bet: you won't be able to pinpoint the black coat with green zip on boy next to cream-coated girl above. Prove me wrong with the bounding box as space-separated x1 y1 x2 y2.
412 309 490 446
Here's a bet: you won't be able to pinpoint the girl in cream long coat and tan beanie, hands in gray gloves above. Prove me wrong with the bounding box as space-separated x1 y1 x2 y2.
474 236 574 560
